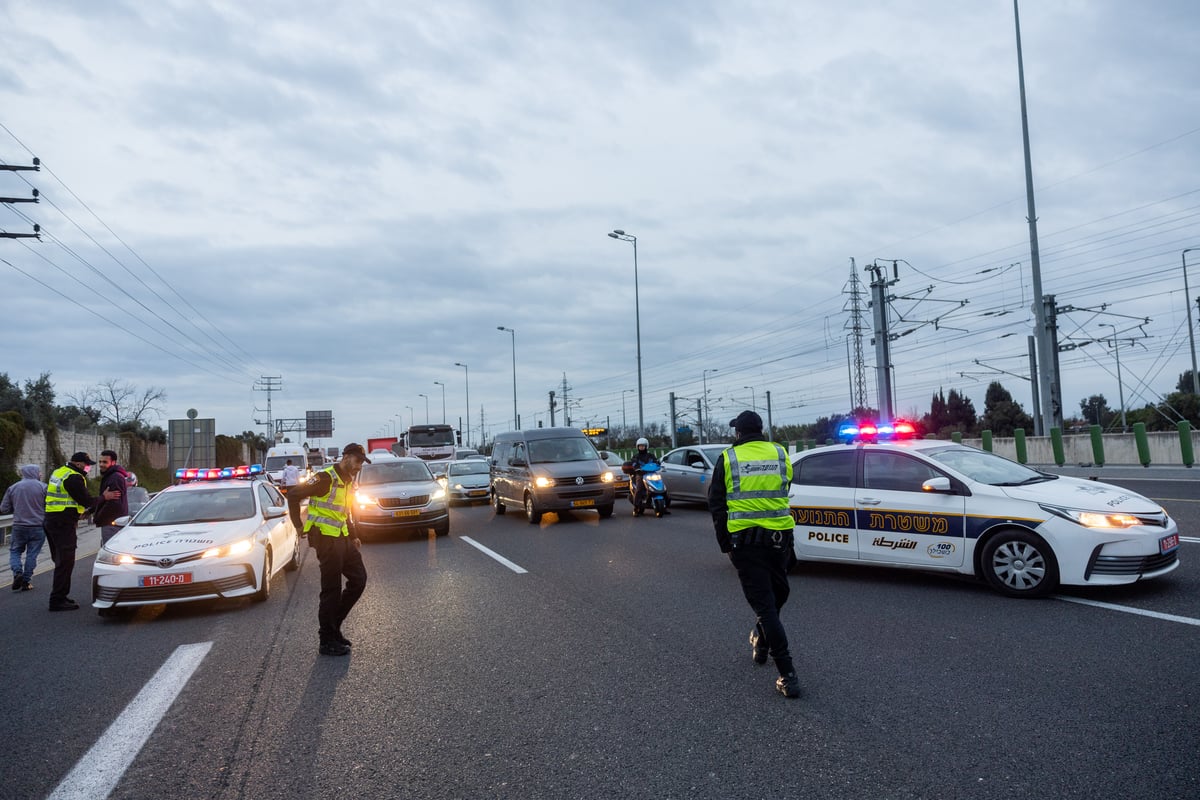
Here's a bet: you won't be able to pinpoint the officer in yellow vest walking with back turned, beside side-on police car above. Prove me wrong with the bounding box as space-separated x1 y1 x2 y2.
708 411 800 697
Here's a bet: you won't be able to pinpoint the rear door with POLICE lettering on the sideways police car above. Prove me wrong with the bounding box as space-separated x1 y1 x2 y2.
788 447 858 561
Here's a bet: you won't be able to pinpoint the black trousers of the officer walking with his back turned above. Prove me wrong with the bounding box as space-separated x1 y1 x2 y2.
730 528 792 674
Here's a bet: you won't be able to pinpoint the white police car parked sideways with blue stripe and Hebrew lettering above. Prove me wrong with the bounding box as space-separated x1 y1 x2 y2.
790 423 1180 597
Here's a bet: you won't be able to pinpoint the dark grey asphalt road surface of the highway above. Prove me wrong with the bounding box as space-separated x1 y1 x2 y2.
0 479 1200 800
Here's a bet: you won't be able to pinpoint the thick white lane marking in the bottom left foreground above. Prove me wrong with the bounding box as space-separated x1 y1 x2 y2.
47 642 212 800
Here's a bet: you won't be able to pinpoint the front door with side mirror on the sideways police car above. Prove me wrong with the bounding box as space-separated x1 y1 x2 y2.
854 446 966 567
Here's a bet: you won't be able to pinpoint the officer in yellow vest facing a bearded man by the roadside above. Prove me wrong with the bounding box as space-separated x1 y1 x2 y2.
44 451 124 612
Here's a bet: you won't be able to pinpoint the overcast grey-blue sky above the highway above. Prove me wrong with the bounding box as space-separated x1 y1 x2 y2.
0 0 1200 445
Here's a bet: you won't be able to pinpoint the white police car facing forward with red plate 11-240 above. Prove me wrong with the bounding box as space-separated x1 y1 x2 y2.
91 467 300 614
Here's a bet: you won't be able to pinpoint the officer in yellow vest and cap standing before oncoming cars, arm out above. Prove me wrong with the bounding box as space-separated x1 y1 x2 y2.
288 444 371 656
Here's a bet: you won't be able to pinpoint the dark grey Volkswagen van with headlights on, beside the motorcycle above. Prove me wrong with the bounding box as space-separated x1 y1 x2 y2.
490 428 620 524
